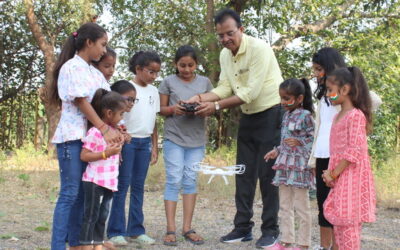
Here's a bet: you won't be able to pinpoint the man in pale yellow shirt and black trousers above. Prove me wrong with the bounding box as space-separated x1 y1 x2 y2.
190 9 283 247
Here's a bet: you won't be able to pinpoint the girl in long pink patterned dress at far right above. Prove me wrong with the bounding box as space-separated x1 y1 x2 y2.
322 67 376 250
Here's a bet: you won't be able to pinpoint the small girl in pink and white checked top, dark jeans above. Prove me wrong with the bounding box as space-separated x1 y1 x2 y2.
79 89 126 250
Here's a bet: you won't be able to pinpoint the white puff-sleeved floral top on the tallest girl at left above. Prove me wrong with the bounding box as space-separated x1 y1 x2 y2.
52 55 110 143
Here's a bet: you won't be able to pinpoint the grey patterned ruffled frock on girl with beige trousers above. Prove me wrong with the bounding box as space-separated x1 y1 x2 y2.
272 108 315 188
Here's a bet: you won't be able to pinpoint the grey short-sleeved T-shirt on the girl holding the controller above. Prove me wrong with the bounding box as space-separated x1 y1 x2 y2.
158 75 212 147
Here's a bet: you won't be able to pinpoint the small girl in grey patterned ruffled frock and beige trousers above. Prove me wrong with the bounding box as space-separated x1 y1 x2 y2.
264 79 315 249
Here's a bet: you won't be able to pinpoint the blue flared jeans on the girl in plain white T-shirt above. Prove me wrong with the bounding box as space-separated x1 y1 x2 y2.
107 137 151 238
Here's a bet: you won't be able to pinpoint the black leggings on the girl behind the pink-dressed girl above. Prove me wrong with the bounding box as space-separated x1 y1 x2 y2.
315 158 332 227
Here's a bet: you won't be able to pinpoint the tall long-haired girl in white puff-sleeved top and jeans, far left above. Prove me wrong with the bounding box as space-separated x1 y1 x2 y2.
50 23 121 250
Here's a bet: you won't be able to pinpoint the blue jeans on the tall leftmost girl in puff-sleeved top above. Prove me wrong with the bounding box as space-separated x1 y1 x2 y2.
51 140 87 250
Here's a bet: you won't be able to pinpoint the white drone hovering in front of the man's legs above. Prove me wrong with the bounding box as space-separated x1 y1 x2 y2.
193 162 246 185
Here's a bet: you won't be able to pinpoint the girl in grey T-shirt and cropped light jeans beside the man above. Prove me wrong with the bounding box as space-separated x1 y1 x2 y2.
159 45 212 246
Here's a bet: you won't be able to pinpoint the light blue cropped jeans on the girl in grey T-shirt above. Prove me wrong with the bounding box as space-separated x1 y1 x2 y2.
163 140 205 201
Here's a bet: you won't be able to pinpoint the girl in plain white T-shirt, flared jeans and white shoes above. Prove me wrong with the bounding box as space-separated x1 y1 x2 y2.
107 51 161 245
